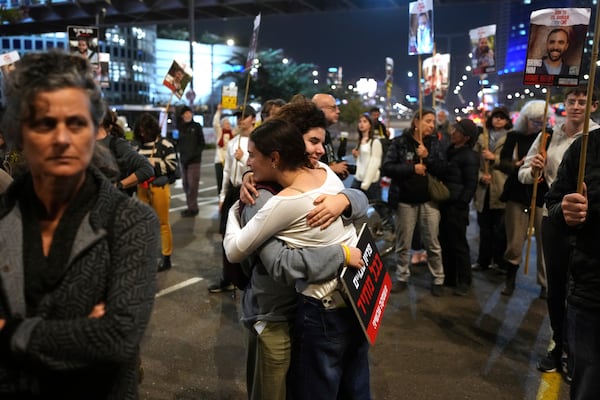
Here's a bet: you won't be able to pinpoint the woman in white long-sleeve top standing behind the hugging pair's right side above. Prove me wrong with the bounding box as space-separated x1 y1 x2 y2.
352 114 383 200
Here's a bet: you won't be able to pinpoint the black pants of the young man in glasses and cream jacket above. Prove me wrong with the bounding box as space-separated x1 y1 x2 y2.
542 217 571 354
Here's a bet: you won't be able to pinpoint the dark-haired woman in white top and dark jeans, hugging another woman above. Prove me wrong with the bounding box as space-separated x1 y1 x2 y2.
224 118 370 399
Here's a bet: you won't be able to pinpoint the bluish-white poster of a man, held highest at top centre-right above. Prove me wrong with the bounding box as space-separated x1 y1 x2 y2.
408 0 433 55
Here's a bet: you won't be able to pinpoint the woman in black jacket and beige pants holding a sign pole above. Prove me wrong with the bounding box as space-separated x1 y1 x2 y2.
383 109 444 296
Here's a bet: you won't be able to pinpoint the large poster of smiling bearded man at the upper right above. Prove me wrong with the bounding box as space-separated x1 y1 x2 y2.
523 8 591 86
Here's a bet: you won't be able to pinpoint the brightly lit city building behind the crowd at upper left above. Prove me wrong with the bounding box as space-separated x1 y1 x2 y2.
0 26 246 113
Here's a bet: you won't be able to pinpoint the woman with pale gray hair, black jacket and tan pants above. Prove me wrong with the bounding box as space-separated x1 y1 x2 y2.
498 100 547 296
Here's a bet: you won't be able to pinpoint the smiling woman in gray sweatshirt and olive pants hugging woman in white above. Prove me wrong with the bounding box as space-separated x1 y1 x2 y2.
228 102 368 400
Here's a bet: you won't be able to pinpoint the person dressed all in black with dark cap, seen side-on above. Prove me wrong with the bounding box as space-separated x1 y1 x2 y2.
440 119 479 296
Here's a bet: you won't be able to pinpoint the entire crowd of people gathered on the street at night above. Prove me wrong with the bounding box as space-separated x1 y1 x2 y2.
0 51 600 399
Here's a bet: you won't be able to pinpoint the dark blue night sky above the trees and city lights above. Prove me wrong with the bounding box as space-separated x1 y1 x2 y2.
196 2 497 85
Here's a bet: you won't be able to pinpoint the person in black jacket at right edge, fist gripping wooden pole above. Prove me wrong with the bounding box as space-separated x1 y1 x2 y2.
546 129 600 400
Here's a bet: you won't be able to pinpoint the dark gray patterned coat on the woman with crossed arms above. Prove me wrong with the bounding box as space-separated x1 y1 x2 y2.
0 169 159 399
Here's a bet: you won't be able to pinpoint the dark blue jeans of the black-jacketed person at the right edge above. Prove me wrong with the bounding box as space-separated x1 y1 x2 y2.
567 304 600 400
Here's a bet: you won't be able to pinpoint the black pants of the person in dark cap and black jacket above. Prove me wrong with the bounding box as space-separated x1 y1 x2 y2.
440 203 471 286
